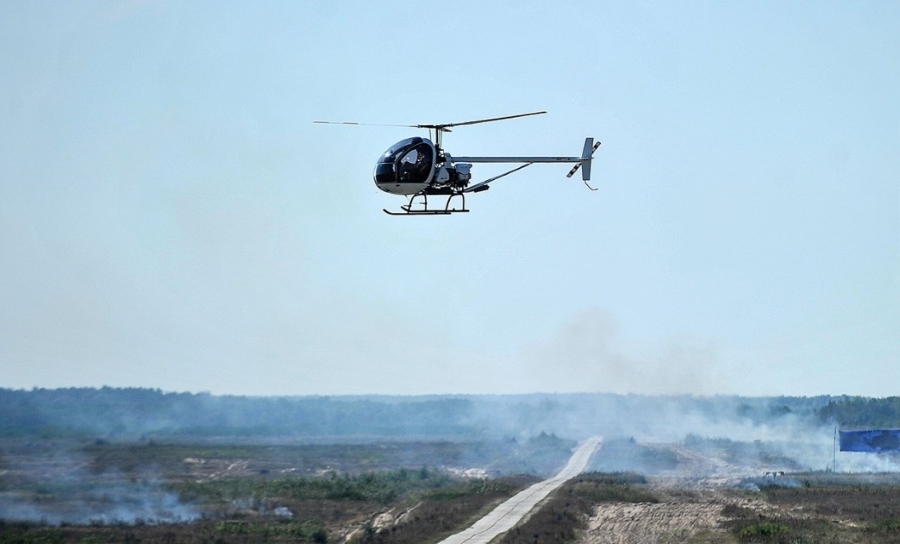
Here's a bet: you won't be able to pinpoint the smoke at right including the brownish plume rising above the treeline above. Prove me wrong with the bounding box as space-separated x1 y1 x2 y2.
482 308 900 476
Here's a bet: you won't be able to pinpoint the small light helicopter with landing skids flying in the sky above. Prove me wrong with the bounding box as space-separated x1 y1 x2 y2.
313 111 600 216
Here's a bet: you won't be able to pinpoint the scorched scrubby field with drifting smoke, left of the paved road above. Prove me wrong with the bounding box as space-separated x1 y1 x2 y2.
0 434 571 544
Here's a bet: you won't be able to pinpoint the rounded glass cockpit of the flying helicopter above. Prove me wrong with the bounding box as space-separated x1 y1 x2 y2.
374 136 437 195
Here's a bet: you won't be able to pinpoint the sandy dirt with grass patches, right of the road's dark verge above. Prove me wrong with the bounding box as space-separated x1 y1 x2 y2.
581 444 900 544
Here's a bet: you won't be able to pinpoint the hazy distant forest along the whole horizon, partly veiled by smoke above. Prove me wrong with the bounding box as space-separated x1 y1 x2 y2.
0 387 900 440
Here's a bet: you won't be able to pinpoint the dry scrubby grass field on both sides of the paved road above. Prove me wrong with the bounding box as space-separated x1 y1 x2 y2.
0 436 900 544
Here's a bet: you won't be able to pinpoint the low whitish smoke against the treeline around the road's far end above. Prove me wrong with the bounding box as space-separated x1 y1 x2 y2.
464 394 900 481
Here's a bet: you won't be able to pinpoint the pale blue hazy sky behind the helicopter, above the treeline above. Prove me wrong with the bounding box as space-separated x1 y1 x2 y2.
0 0 900 396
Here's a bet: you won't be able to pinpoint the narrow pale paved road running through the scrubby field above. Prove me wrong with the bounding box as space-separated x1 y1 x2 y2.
441 436 602 544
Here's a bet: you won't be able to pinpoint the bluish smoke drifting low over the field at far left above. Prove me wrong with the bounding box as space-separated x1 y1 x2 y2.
0 448 200 525
